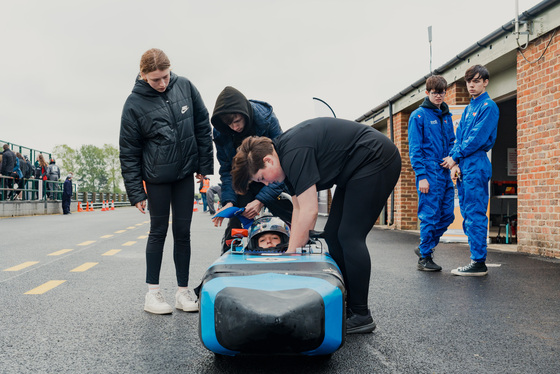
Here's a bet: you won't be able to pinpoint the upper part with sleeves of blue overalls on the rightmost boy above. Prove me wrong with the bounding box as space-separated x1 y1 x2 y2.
449 92 500 163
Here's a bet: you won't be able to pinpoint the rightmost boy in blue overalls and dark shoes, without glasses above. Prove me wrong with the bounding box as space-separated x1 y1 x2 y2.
442 65 500 276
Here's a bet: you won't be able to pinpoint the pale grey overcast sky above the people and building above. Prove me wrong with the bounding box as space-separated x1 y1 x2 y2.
0 0 539 174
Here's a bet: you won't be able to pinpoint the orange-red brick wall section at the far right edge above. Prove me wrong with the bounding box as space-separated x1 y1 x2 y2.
517 29 560 257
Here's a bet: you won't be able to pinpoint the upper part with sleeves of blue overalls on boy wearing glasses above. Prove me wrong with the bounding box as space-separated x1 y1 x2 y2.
408 97 455 180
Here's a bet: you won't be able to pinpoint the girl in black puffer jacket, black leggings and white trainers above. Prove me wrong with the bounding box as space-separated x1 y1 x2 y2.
119 48 214 314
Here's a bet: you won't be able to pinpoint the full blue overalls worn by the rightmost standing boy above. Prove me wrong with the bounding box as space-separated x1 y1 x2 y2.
449 92 500 262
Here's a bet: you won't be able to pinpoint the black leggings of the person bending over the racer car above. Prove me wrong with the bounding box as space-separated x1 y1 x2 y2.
324 156 401 314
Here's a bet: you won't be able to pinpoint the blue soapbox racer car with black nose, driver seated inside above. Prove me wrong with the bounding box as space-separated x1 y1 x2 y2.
199 217 346 356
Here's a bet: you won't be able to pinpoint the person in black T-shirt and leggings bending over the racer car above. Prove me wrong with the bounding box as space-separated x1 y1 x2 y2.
232 118 401 334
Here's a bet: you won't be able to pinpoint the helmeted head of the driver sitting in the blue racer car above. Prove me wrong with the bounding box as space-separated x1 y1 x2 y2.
248 216 290 251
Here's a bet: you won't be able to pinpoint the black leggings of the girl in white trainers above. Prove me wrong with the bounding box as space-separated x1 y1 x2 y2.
146 175 194 287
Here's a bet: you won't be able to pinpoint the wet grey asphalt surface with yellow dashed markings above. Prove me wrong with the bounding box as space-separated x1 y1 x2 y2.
0 208 560 373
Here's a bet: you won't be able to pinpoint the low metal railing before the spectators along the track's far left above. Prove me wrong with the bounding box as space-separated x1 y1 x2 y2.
0 175 130 208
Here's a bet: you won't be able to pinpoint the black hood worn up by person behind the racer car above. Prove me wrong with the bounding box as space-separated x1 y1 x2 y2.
210 86 254 139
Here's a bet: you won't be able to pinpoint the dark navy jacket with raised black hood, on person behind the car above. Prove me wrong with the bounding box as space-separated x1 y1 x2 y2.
211 86 284 206
